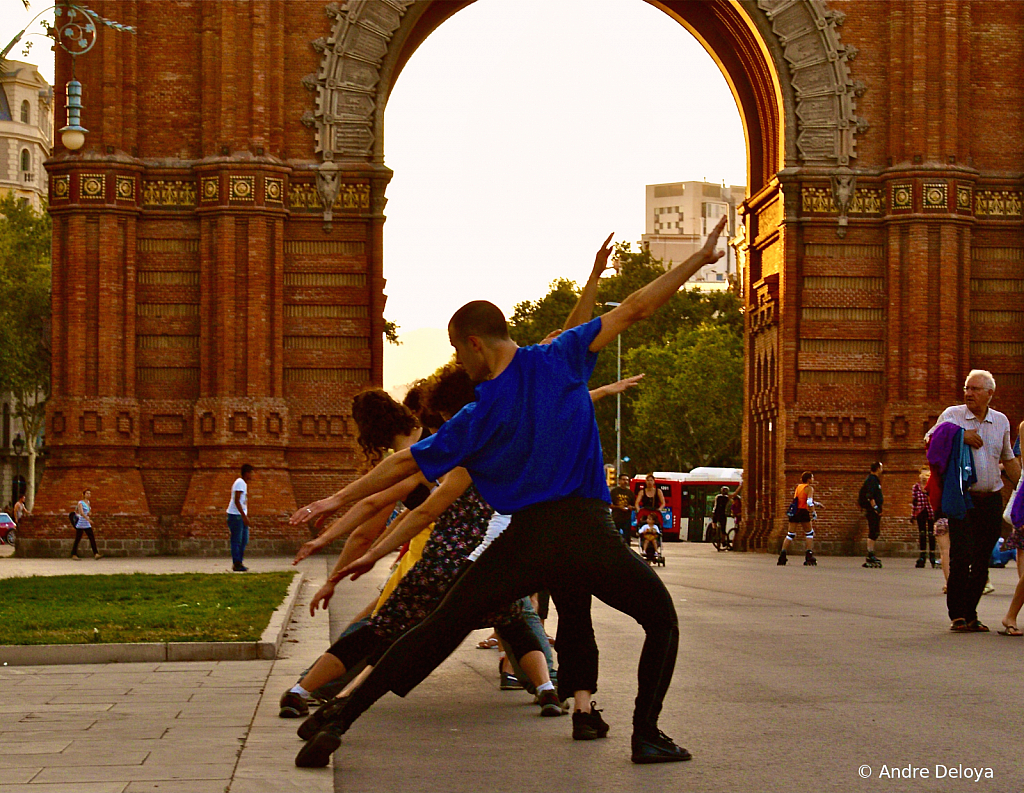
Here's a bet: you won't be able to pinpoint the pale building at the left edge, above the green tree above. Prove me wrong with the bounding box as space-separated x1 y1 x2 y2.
0 60 53 209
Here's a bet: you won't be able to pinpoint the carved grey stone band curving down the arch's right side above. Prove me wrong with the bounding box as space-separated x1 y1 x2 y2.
757 0 868 164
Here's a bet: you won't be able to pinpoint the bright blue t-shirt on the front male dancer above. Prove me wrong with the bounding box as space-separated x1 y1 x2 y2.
412 318 610 514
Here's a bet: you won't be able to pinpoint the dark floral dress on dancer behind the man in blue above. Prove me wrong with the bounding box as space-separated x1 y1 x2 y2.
370 485 522 642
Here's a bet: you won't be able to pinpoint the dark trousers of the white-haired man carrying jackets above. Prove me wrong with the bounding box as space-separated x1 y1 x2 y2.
946 493 1002 622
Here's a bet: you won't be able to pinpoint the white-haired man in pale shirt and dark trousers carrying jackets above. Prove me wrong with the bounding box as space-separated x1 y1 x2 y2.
925 369 1021 633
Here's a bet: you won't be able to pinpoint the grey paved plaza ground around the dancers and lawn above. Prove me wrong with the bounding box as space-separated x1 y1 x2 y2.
0 544 1024 793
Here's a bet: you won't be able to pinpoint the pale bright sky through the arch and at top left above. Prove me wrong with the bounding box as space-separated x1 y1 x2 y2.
0 0 746 390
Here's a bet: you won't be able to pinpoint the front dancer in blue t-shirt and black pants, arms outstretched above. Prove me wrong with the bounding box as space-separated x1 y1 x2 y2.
292 218 725 766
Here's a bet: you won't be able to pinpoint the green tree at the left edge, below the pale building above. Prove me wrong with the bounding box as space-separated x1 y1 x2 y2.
0 194 50 509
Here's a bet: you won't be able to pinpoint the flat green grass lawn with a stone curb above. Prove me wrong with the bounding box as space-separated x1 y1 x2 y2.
0 572 295 644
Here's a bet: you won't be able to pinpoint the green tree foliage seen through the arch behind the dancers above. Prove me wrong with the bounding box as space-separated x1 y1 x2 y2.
509 243 743 473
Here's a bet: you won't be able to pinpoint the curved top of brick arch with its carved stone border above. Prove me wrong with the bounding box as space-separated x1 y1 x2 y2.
303 0 866 198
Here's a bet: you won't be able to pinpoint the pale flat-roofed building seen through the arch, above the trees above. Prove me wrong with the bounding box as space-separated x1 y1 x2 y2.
641 181 746 289
